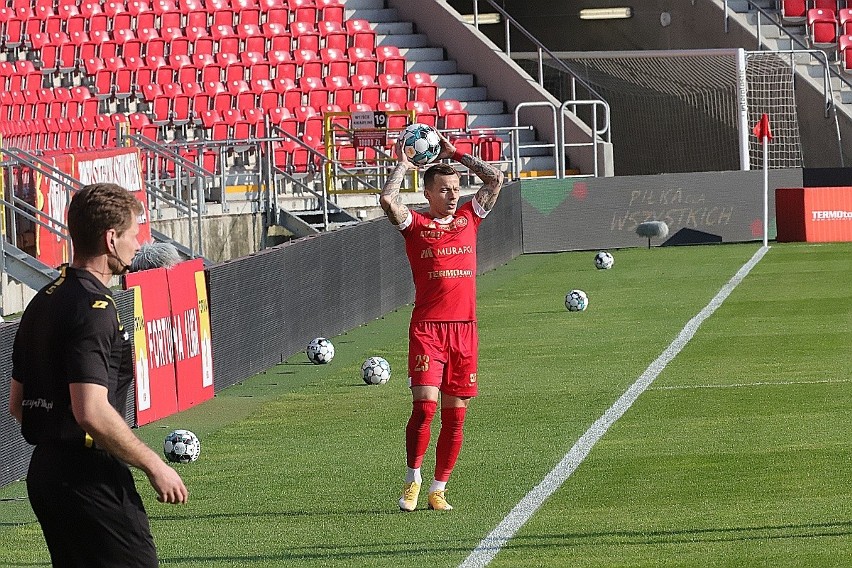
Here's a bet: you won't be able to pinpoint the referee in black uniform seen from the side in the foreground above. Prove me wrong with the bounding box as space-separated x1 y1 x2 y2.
9 183 188 568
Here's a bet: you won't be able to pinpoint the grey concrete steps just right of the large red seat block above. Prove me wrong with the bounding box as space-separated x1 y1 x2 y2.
346 0 553 172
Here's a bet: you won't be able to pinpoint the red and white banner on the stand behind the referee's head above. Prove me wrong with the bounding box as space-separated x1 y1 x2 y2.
32 148 151 267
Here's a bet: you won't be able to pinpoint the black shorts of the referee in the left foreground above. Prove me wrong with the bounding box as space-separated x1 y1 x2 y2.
27 444 157 568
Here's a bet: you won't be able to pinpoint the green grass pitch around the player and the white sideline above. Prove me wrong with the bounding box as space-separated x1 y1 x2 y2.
0 243 852 568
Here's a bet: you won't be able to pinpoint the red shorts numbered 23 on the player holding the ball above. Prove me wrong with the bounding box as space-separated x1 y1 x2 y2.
408 321 479 397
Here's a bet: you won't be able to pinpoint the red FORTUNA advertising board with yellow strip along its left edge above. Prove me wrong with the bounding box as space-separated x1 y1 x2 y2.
125 268 178 426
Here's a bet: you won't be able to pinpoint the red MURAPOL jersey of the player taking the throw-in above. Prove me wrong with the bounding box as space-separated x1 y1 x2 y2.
401 200 482 322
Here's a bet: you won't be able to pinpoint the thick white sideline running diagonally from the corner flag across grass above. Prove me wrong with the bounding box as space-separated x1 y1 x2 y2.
459 246 769 568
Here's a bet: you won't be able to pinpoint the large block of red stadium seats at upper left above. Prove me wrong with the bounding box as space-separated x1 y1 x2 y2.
0 0 512 171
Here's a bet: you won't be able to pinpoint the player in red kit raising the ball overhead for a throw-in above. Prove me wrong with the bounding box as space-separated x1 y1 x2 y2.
379 132 503 511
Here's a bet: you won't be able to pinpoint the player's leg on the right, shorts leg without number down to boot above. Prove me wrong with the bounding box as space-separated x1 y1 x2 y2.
429 322 479 510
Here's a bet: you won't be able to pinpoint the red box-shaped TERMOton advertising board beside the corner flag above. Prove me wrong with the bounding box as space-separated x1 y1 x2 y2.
775 187 852 243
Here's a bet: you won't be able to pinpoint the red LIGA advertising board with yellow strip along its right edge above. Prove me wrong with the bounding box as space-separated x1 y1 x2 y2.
166 259 213 411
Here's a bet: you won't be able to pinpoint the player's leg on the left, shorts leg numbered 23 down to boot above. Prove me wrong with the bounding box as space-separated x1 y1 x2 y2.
399 324 443 511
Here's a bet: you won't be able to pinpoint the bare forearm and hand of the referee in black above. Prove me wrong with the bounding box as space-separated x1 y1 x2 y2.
70 383 188 503
